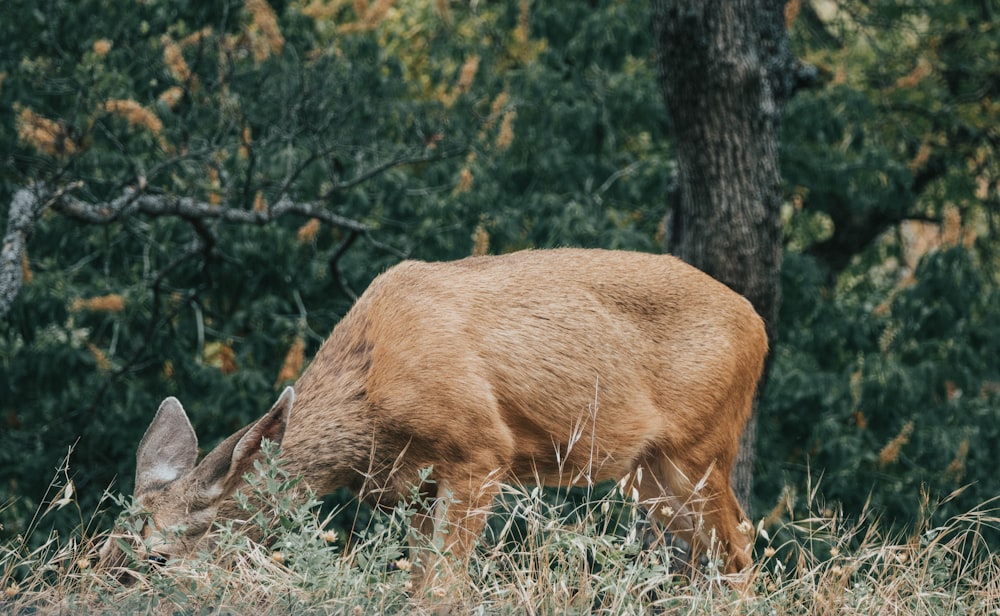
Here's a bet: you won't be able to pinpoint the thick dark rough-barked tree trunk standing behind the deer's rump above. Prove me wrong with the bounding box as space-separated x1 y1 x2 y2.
653 0 795 515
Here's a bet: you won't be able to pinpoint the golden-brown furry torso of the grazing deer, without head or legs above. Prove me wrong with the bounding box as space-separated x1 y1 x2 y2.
286 249 766 490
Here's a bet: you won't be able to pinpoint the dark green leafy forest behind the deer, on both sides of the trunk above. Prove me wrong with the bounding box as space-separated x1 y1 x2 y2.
0 0 1000 552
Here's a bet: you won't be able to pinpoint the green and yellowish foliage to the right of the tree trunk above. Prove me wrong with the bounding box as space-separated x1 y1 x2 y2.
757 2 1000 528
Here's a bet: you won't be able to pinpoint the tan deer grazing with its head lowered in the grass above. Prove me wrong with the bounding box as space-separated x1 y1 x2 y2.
101 248 768 596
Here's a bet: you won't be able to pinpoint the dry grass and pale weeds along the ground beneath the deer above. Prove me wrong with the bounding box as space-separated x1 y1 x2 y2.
0 450 1000 616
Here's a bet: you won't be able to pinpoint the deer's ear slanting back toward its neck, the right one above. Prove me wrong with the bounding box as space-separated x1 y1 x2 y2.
193 387 295 498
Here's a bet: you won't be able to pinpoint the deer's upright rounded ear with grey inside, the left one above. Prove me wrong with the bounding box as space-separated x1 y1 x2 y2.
134 398 198 494
